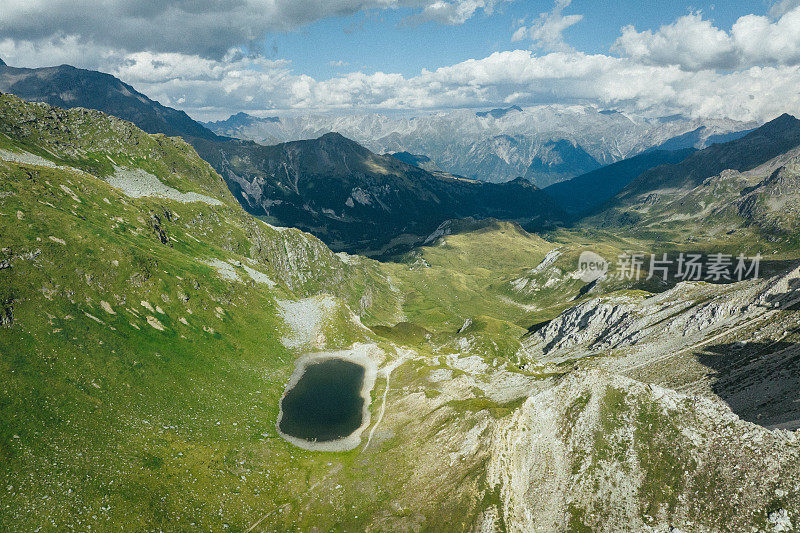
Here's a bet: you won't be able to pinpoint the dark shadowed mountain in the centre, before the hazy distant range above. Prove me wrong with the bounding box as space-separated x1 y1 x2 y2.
189 133 564 255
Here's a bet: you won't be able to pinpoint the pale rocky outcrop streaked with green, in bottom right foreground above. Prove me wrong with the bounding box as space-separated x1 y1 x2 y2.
487 371 800 531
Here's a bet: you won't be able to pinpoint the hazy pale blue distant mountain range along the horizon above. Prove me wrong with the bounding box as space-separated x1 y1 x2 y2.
207 105 757 187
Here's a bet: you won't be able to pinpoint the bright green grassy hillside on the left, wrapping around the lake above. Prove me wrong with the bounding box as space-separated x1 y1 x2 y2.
0 96 546 531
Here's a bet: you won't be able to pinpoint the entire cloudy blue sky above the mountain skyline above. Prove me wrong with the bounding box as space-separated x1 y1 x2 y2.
0 0 800 121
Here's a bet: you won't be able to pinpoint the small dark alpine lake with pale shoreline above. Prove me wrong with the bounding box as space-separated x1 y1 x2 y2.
279 359 365 441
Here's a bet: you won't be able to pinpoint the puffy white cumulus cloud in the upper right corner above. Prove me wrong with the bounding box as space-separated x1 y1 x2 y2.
614 7 800 71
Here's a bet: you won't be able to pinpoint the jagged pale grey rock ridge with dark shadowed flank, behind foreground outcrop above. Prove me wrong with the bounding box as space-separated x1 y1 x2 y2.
524 268 800 428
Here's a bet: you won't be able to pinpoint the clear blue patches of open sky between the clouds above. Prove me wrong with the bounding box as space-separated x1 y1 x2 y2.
264 0 769 78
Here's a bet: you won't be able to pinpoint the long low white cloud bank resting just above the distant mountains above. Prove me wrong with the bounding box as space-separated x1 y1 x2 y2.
12 43 788 120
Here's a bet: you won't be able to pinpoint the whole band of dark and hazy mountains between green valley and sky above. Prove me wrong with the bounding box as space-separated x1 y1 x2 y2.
0 58 797 255
